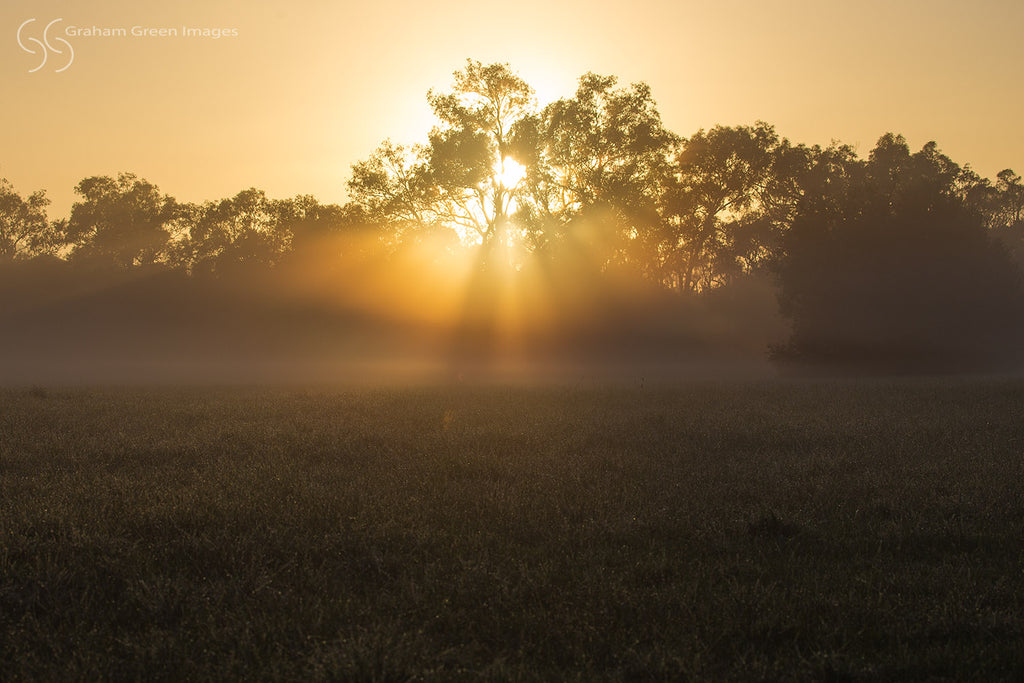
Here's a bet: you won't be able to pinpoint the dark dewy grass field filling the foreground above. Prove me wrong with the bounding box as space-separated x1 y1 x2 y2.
0 381 1024 681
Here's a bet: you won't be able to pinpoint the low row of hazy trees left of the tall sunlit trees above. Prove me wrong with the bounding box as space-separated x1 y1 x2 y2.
0 179 356 274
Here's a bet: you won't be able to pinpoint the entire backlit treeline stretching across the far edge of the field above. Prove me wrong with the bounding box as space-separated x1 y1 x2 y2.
0 60 1024 372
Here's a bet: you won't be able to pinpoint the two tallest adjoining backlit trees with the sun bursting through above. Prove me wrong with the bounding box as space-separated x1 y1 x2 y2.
348 60 679 268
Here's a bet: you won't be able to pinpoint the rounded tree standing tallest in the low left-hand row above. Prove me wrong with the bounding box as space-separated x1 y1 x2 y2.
62 173 177 268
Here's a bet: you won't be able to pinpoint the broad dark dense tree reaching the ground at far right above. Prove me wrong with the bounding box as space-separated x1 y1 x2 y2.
777 134 1024 371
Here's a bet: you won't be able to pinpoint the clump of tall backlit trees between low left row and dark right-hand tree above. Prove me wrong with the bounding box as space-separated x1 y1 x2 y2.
349 60 790 291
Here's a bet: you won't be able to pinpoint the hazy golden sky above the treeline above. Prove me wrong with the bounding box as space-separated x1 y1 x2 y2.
0 0 1024 217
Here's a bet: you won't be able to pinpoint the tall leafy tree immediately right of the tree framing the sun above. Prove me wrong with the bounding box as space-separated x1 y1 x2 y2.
516 74 679 266
